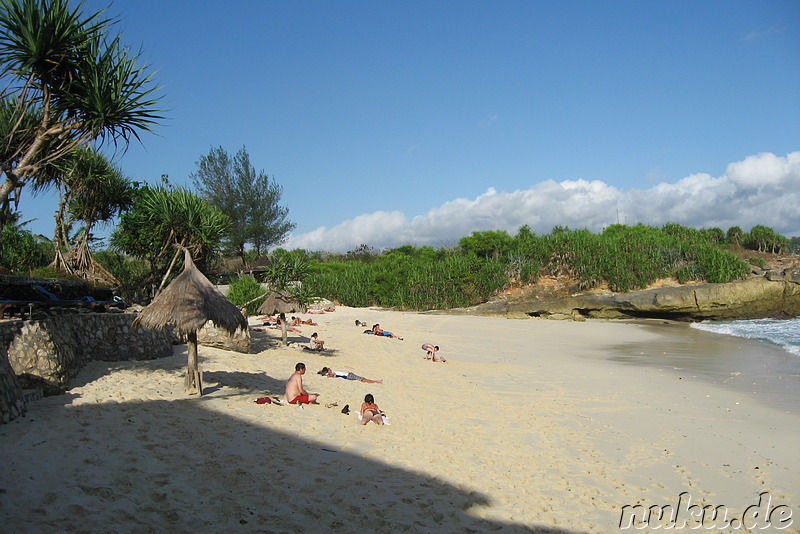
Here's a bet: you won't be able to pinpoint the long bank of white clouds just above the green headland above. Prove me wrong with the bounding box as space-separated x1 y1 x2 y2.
283 152 800 252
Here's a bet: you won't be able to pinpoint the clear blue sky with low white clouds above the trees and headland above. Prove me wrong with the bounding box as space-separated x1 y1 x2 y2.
20 0 800 251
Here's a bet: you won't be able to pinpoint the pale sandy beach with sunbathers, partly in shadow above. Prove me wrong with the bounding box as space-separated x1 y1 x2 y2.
0 307 800 533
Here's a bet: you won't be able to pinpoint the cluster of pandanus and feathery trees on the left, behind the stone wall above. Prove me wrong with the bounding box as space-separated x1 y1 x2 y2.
0 0 294 294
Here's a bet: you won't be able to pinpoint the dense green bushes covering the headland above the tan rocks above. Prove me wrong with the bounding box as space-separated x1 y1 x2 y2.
306 224 789 310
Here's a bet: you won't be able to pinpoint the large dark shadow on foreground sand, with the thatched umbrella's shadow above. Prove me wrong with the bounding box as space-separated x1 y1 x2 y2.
0 366 584 534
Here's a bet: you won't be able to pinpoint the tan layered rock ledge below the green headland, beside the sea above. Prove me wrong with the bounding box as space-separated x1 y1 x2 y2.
454 266 800 321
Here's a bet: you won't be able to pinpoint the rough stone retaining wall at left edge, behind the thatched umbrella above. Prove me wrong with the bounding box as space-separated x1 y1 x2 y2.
0 313 173 422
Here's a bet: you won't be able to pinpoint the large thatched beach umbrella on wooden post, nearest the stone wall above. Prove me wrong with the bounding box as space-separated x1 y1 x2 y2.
133 249 247 396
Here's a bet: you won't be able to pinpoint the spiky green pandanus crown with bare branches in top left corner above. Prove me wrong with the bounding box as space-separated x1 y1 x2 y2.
0 0 162 214
